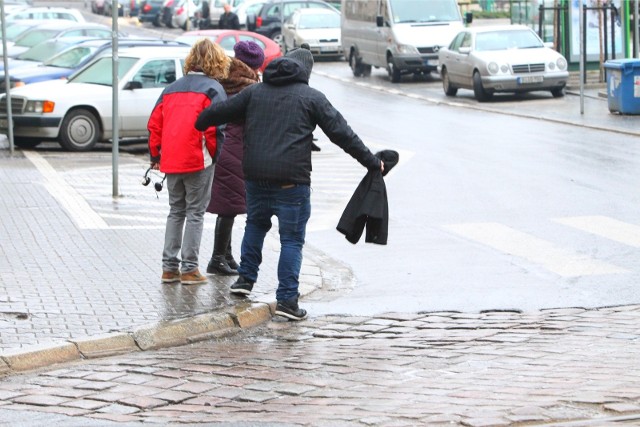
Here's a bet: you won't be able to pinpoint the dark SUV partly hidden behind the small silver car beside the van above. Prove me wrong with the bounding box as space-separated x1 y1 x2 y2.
247 0 337 45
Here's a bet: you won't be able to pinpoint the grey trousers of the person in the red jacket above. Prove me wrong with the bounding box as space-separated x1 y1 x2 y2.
162 165 215 273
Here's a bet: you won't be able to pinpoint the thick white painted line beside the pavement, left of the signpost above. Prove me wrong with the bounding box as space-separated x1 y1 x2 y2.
23 151 109 230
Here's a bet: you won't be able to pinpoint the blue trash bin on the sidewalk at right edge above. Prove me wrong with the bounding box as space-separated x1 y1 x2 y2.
604 59 640 114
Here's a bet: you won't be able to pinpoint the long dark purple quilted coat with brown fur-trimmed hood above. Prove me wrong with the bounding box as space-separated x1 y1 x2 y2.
207 58 259 216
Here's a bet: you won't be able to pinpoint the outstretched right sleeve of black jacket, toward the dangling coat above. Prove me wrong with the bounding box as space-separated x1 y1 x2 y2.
313 93 380 169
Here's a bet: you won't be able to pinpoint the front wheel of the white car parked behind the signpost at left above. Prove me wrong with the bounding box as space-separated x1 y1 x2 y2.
60 109 100 151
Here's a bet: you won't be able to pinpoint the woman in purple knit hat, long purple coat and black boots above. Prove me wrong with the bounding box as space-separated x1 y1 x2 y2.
207 41 264 276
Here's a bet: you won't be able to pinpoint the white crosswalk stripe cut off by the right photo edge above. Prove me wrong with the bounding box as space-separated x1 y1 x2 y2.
554 215 640 248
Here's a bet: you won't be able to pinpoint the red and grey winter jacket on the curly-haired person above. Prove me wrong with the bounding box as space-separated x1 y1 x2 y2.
147 72 227 173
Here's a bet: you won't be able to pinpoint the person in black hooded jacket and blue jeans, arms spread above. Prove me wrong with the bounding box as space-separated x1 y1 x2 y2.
195 49 384 320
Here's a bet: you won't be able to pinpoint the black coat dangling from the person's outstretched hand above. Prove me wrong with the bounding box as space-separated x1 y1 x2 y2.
336 150 399 245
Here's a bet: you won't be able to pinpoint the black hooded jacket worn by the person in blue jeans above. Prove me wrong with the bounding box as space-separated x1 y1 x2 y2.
196 57 380 185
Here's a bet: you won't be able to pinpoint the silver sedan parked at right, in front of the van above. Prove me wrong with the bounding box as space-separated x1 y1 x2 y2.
438 25 569 102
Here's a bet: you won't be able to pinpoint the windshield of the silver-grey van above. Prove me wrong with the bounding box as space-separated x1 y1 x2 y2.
391 0 462 24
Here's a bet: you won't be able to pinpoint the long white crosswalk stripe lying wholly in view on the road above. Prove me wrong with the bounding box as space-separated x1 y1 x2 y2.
444 222 627 277
